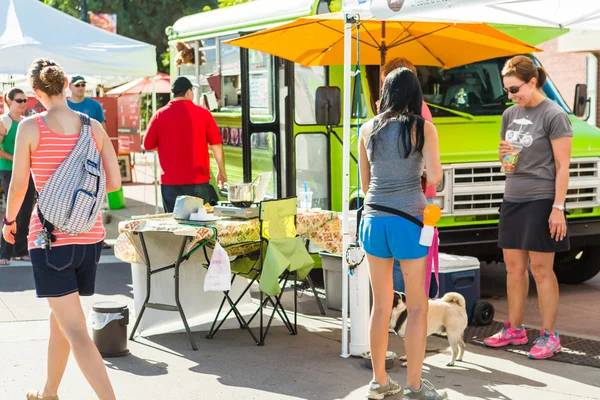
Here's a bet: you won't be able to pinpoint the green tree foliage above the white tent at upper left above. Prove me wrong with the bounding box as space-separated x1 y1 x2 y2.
40 0 218 72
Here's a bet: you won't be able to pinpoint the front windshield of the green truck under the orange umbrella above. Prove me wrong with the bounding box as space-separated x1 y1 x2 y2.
417 57 571 117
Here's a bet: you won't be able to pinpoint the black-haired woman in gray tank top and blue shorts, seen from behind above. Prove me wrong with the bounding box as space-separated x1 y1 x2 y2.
360 68 447 399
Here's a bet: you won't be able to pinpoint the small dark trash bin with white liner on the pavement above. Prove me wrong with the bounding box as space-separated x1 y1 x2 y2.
91 302 129 357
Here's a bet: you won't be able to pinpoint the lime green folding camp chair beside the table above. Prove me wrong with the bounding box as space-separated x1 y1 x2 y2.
207 197 314 346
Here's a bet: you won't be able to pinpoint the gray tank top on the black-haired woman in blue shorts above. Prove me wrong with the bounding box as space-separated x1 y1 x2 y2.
364 119 427 217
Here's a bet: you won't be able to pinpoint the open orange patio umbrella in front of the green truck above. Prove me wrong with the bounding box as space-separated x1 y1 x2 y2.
226 13 540 68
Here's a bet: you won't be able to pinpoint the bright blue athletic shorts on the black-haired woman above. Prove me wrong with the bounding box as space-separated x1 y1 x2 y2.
359 215 429 261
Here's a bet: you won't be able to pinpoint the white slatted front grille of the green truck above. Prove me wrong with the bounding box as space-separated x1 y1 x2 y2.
440 158 600 215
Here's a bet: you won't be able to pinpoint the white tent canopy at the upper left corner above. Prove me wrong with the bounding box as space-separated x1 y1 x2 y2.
0 0 157 77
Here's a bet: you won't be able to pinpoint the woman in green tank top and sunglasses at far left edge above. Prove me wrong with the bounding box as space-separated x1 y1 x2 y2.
0 88 35 265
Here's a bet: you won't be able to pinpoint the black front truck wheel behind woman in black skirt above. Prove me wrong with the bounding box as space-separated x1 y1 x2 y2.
554 247 600 285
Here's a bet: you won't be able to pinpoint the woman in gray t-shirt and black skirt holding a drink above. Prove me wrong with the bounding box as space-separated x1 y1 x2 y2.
485 56 573 359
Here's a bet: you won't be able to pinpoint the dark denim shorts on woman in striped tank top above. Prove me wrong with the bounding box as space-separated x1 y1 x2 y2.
29 242 102 297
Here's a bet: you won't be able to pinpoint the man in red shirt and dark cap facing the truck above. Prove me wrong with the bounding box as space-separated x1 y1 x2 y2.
144 76 227 212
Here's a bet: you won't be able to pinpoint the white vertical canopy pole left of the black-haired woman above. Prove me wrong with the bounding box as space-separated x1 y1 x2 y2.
342 14 352 358
